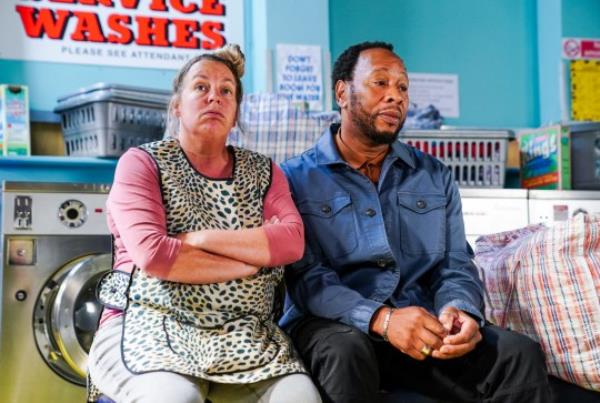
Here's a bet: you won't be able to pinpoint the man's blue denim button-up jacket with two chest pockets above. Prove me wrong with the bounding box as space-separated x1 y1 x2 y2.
280 125 483 333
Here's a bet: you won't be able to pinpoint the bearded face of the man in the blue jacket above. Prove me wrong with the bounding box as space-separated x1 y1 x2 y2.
347 48 408 144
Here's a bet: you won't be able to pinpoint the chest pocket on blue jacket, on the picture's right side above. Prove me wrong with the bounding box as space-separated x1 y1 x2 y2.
398 192 447 254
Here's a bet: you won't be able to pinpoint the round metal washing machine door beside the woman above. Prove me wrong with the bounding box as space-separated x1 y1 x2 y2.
33 254 112 385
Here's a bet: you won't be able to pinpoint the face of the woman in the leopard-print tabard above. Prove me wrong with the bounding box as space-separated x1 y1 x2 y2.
175 60 237 141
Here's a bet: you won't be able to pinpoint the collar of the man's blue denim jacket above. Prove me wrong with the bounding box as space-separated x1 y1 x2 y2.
315 123 415 168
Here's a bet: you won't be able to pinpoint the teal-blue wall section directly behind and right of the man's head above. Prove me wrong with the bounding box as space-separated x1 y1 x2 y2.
329 0 539 127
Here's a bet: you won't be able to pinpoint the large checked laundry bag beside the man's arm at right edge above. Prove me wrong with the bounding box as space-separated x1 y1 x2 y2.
475 214 600 391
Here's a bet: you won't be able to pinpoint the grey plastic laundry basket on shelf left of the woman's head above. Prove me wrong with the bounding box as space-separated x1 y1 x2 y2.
54 83 170 157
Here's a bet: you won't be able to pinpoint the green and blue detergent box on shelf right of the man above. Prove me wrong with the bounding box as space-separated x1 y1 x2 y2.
518 125 571 190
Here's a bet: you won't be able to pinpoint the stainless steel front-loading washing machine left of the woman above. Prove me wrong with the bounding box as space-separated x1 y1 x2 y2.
0 182 112 403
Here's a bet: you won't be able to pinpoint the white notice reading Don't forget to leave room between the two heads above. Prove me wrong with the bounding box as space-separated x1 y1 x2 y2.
275 44 323 111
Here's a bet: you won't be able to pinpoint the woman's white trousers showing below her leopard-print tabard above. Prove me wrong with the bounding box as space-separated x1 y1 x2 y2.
88 318 321 403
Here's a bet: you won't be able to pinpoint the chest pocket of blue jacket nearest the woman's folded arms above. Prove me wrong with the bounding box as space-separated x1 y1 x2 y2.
298 193 358 258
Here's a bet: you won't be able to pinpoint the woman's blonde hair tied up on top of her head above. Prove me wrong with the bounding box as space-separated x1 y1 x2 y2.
167 44 246 138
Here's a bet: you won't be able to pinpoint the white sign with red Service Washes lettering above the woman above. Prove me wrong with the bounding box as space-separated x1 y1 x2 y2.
0 0 244 69
